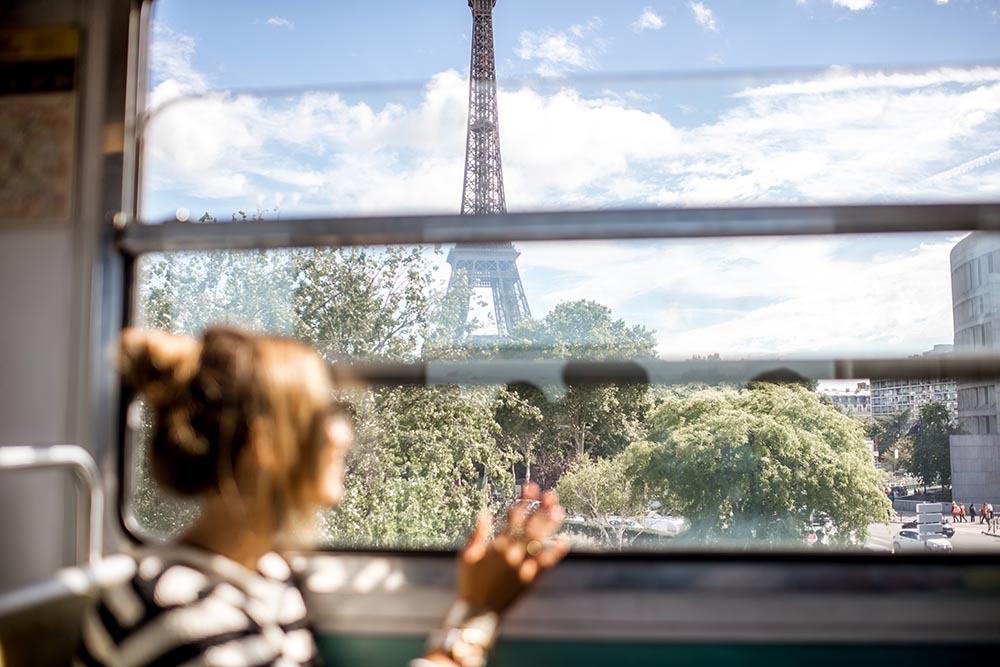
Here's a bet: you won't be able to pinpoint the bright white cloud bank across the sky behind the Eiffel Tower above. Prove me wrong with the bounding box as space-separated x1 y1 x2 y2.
144 34 1000 356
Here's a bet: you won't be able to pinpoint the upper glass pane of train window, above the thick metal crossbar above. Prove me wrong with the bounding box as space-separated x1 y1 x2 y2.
141 0 1000 222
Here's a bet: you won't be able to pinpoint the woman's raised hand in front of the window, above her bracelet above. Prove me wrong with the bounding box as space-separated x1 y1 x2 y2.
458 484 569 614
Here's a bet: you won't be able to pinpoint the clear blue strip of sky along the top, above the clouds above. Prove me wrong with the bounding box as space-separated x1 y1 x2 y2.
154 0 1000 88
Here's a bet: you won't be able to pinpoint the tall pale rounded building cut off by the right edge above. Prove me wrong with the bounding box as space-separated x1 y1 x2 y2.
951 232 1000 504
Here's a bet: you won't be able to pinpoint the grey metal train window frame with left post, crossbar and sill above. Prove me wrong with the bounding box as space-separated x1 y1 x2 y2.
88 5 1000 652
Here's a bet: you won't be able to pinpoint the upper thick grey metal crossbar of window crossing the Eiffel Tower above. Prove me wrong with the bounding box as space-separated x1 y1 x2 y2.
117 202 1000 257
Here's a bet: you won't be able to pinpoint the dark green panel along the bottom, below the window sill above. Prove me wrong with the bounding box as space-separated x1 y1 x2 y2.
318 636 1000 667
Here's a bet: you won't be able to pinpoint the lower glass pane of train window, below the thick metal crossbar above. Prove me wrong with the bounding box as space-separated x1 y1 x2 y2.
125 235 1000 551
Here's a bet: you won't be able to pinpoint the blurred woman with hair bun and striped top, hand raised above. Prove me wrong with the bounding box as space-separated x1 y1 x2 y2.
78 327 567 667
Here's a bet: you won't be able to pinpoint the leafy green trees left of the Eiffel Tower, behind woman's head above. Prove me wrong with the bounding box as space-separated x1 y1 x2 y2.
133 234 500 546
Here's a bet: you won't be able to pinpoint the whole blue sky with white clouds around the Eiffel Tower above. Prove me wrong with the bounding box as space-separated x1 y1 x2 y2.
143 0 1000 366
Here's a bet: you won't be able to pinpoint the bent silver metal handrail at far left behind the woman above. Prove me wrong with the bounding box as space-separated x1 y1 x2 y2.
0 445 104 565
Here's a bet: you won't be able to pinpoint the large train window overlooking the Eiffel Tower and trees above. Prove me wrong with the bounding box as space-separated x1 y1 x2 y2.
122 1 1000 552
